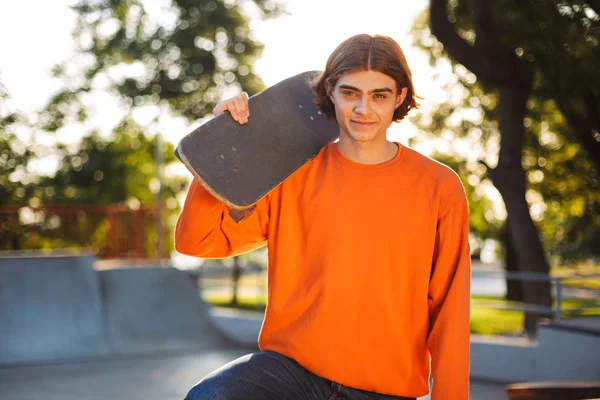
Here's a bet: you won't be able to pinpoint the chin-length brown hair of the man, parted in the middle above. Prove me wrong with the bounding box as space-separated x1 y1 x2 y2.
311 34 419 122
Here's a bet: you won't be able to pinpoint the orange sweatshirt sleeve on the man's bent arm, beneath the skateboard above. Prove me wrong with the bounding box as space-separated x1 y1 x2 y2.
175 179 269 258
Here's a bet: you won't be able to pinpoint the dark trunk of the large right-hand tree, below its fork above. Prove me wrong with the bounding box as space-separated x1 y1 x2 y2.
492 87 552 335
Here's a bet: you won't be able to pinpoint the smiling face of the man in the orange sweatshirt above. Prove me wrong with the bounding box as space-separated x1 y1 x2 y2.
327 70 407 142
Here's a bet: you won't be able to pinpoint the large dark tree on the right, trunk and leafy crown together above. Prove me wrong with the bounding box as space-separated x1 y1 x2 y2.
415 0 600 332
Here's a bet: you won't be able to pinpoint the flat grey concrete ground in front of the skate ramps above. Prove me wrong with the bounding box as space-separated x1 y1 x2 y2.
0 350 506 400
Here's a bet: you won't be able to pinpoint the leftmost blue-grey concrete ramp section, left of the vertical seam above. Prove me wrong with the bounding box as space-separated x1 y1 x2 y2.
0 256 109 365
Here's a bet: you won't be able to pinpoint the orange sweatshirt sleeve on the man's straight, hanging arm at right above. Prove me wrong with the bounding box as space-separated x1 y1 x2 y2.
427 188 471 400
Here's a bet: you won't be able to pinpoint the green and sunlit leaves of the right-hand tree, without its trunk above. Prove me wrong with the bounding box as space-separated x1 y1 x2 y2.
413 0 600 257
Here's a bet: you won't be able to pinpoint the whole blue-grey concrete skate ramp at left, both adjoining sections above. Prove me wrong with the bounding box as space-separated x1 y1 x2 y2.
0 256 242 366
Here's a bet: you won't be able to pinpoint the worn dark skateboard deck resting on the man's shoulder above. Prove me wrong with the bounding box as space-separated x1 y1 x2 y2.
175 71 339 222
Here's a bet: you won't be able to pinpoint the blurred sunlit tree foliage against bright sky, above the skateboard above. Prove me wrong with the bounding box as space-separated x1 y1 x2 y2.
43 0 281 131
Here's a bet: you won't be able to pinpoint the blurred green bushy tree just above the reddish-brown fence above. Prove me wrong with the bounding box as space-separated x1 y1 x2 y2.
34 119 186 204
